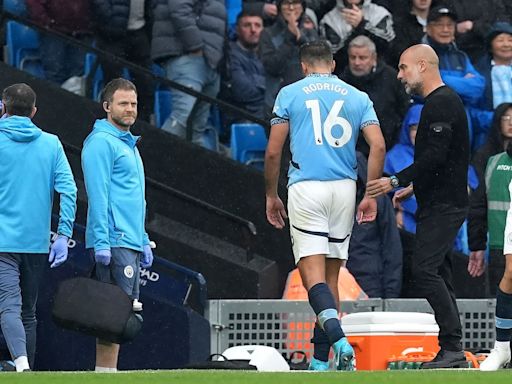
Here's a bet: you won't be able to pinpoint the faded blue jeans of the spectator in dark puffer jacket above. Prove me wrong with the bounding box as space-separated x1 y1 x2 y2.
162 55 220 150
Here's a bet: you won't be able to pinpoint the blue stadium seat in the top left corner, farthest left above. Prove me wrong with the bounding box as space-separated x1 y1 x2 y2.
5 20 40 68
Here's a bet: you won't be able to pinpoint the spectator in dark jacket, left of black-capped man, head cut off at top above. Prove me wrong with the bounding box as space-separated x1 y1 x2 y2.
388 0 432 68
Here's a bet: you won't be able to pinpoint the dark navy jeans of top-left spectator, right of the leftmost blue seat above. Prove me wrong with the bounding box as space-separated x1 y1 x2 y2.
40 34 85 84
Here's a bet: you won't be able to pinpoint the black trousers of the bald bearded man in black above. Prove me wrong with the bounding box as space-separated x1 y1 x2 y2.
412 204 467 351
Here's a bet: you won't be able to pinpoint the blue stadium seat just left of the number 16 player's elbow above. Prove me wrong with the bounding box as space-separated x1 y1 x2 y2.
231 124 268 170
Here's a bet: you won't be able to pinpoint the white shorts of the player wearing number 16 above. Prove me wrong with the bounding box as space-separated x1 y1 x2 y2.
288 179 356 264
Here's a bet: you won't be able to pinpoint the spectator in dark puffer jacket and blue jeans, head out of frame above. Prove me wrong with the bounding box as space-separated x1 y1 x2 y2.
151 0 226 150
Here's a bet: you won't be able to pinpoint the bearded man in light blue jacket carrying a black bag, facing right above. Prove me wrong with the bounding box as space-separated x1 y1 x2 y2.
82 78 153 372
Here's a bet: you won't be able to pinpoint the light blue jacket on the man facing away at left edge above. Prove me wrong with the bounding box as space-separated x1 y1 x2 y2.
0 116 76 253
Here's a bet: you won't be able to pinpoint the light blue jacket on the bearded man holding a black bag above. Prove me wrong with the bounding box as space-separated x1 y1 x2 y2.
82 119 149 251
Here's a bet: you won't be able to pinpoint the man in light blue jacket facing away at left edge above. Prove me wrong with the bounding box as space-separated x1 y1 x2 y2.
0 84 76 371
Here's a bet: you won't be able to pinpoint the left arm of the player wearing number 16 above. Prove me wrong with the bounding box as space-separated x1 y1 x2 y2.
265 118 290 229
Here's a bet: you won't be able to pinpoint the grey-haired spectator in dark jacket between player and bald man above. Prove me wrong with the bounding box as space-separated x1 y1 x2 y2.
340 35 411 156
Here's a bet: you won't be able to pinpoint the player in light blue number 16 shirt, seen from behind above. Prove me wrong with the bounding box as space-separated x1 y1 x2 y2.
265 41 385 371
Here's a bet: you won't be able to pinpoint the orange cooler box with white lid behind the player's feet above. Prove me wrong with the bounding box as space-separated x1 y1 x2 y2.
341 312 439 370
